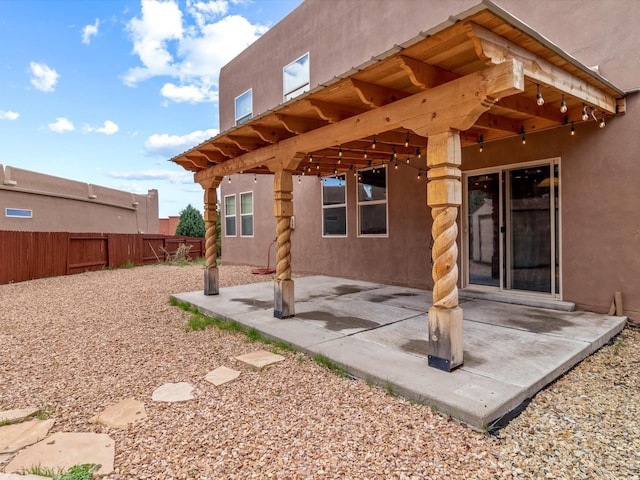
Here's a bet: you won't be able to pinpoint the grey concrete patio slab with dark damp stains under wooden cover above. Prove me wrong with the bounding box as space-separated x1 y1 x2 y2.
174 276 626 429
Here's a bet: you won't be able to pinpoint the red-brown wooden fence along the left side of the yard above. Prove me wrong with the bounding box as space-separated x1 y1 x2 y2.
0 231 205 285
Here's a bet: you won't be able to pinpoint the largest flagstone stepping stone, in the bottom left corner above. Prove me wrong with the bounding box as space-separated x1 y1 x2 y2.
5 432 115 475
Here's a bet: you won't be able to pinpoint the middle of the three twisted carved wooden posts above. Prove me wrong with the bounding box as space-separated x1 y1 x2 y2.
273 169 295 318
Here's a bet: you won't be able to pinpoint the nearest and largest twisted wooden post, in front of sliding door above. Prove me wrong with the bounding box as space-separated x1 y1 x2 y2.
427 130 463 372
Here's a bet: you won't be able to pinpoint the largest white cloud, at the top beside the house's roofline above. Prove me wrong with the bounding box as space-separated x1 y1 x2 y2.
123 0 267 103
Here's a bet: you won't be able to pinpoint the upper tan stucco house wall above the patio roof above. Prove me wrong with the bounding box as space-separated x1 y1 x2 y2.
220 0 640 131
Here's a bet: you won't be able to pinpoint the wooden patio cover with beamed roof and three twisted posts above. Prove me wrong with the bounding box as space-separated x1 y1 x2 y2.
171 2 625 371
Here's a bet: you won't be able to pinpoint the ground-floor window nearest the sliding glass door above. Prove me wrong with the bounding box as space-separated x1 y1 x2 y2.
358 167 387 236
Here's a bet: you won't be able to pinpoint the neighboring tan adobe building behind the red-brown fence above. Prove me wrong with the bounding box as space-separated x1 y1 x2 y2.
0 165 159 233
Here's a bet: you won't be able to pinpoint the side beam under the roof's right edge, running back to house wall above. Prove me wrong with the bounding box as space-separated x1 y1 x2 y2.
466 22 616 114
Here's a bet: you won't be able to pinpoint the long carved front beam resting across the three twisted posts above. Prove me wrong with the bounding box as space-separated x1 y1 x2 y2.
196 60 524 181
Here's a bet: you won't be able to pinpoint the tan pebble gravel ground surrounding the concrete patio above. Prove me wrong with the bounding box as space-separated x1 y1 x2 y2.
0 266 640 479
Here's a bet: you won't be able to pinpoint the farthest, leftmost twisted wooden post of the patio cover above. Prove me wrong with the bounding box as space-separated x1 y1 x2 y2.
201 177 222 295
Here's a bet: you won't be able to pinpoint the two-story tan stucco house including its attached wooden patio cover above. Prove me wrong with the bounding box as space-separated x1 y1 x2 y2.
172 0 640 369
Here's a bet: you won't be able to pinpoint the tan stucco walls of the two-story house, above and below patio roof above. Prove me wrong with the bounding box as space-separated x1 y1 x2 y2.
220 0 640 319
